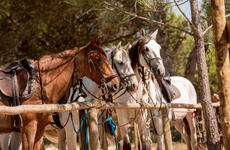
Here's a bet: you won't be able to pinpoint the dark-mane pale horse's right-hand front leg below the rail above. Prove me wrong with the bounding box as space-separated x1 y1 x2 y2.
137 112 151 150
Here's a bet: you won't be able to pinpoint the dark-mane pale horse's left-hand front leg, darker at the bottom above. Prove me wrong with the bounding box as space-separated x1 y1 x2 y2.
116 109 131 150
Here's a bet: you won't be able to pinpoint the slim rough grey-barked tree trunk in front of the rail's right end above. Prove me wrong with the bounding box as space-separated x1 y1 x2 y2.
190 0 221 150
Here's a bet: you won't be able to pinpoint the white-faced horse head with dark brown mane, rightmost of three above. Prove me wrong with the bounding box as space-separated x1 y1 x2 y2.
129 29 165 79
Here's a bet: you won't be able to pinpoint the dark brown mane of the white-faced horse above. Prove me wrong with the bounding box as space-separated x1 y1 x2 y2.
129 35 152 70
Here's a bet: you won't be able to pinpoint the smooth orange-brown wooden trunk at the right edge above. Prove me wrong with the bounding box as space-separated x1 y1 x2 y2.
211 0 230 150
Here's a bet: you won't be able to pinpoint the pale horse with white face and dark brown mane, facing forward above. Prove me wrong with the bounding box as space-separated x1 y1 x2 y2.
111 30 165 149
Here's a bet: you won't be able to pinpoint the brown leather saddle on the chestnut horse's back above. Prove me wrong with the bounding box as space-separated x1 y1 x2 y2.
0 61 29 97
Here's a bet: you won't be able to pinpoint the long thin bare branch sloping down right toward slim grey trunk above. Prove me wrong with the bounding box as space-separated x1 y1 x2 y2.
103 1 193 36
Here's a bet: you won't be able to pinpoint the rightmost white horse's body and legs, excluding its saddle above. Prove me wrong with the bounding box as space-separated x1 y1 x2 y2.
149 76 198 150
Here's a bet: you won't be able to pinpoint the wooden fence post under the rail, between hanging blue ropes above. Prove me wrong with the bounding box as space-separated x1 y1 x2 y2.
88 108 100 150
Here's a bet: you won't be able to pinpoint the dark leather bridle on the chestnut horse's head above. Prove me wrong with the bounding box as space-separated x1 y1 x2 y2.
72 47 117 97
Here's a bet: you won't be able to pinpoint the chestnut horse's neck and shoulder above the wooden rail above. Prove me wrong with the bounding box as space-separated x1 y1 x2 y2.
31 50 76 104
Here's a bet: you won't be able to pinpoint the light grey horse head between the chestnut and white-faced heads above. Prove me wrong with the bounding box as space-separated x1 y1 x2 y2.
110 42 138 93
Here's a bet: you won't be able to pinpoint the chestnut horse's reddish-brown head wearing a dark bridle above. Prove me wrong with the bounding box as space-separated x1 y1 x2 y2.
79 36 119 93
